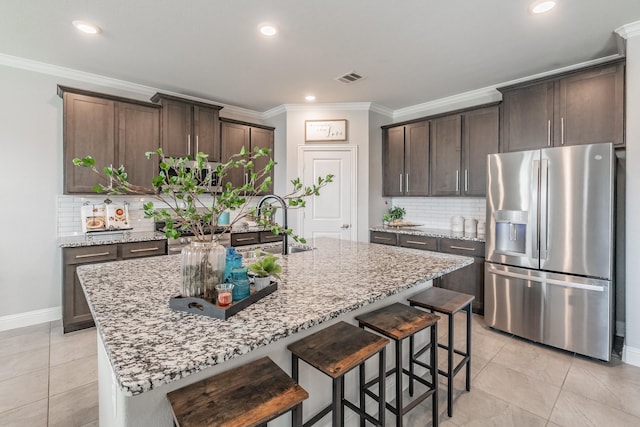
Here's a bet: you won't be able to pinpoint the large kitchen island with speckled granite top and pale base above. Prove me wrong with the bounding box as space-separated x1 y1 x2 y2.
78 238 472 427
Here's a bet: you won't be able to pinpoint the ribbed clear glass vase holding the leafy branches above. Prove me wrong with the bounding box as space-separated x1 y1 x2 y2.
181 241 226 302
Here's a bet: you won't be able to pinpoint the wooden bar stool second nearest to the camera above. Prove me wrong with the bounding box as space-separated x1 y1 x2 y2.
288 322 389 427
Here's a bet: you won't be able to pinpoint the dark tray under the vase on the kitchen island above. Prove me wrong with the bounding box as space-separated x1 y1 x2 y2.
169 281 278 320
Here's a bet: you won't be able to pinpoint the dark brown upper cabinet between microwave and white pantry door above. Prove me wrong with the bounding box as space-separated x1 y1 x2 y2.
220 118 275 195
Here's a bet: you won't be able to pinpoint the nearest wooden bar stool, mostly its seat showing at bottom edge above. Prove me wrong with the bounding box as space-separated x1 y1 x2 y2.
167 357 309 427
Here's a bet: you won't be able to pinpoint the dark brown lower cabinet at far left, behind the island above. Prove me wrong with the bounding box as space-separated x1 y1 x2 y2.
62 240 167 333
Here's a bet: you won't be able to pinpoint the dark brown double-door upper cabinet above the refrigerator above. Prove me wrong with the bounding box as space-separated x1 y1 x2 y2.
500 61 624 152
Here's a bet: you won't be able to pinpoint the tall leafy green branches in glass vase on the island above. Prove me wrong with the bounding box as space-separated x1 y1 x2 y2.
73 147 333 300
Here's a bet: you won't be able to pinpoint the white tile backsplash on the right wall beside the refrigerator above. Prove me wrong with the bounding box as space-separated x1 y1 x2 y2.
389 197 486 230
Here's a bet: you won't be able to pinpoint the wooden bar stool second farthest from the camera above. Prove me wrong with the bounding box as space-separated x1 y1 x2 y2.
356 303 440 427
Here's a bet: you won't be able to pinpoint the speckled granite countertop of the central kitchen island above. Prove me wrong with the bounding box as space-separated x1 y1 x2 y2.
78 238 473 395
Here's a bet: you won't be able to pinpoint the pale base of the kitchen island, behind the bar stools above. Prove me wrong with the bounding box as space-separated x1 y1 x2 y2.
98 281 432 427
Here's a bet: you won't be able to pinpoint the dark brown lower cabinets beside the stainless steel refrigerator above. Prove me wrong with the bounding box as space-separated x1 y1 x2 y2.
370 231 485 314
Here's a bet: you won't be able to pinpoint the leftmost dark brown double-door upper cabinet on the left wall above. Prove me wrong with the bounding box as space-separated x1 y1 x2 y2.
58 86 160 194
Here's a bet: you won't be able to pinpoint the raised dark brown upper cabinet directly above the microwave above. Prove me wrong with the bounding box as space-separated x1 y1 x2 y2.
151 93 222 162
